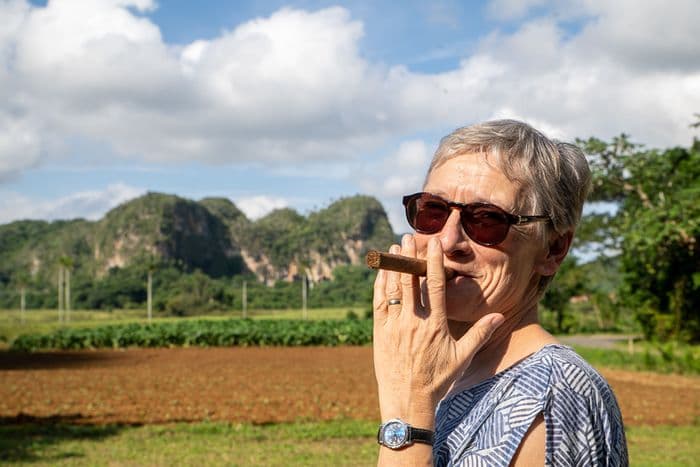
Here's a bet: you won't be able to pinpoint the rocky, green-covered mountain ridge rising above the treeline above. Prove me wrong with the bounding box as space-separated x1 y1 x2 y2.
0 193 395 285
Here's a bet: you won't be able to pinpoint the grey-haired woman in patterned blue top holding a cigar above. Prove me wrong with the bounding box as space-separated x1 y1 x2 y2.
374 120 628 466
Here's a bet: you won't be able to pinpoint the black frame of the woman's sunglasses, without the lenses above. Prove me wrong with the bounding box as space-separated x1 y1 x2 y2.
403 191 551 246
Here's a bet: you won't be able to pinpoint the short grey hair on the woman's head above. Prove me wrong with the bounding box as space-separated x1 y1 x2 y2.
426 120 591 291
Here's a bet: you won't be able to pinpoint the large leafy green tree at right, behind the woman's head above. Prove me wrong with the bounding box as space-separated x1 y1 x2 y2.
581 135 700 341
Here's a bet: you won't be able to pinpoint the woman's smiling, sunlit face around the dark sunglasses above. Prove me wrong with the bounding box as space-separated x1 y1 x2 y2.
415 154 545 323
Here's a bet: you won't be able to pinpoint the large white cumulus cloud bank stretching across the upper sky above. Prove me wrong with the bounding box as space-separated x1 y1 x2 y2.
0 0 700 188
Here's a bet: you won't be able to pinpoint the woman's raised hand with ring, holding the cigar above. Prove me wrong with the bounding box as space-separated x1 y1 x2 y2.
374 235 503 430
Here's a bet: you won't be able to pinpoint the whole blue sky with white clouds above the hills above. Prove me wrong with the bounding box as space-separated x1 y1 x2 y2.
0 0 700 232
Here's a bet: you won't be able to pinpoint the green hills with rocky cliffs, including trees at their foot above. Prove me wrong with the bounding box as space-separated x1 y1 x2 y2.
0 193 395 314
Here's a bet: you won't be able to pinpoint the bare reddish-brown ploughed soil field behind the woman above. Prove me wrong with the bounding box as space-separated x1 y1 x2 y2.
0 347 700 425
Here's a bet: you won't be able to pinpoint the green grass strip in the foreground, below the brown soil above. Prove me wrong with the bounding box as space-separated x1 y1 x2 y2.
0 420 700 466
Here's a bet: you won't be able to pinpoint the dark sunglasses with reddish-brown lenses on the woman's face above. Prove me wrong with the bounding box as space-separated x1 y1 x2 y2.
403 192 550 246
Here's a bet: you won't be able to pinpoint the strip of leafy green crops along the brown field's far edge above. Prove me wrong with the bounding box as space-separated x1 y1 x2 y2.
11 319 372 352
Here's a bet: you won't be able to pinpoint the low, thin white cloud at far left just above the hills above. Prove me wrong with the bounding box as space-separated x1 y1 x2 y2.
0 183 146 224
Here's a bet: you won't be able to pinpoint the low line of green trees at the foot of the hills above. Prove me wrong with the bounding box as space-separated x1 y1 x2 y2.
0 263 374 316
